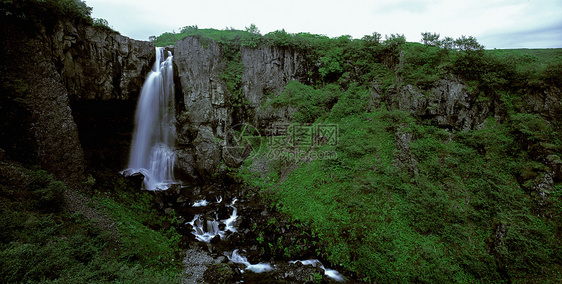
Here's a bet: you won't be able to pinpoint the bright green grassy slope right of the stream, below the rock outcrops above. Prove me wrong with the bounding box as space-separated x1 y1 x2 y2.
235 83 562 283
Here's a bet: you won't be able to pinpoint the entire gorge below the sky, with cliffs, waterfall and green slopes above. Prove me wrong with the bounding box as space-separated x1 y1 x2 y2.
0 1 562 283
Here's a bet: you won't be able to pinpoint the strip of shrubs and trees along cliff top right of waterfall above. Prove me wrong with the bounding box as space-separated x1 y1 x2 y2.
151 25 562 92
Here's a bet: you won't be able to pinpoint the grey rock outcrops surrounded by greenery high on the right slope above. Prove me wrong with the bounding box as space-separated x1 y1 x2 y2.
372 76 562 130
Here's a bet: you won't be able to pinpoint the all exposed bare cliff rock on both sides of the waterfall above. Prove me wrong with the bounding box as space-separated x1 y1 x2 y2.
0 11 562 187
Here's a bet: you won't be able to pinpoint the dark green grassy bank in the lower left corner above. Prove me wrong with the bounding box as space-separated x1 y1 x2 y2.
0 161 181 283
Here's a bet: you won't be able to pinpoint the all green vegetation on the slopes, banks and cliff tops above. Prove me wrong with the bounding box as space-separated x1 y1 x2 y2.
0 0 562 283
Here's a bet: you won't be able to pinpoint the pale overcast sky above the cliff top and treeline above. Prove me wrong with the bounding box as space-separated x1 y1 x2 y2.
86 0 562 49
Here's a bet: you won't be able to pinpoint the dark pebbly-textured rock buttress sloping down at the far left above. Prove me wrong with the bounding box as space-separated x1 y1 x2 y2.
0 30 85 187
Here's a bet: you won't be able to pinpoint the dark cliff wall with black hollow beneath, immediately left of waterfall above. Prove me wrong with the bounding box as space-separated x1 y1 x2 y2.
50 22 156 178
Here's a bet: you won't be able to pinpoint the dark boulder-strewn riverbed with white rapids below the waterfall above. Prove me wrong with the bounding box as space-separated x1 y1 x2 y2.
136 179 350 283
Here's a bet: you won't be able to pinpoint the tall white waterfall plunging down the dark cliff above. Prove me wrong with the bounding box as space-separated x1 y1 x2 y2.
123 47 176 190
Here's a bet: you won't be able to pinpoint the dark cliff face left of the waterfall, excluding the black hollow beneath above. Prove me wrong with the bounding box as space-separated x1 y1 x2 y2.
0 15 154 185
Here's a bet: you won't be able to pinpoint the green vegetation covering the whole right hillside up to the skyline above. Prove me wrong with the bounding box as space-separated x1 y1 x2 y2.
218 31 562 283
